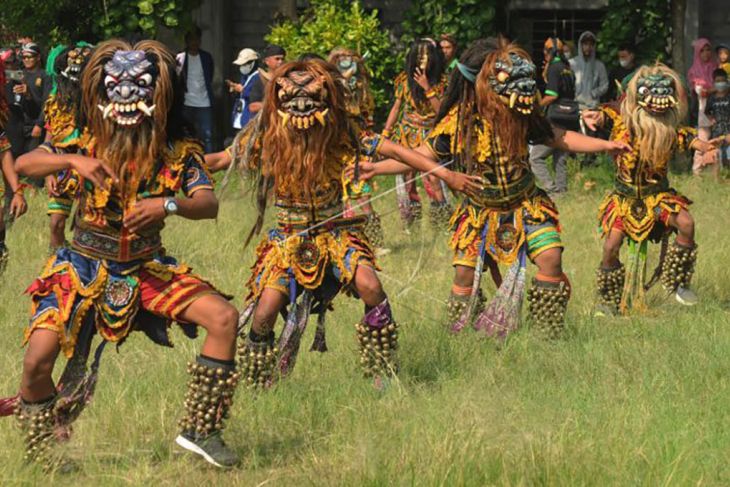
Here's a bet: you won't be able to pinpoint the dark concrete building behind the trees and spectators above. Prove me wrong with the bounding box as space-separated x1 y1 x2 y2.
185 0 730 145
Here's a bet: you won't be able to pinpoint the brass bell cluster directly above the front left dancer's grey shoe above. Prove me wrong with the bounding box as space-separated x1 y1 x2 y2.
180 361 240 438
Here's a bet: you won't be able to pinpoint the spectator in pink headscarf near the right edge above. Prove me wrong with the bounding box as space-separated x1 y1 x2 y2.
687 38 717 173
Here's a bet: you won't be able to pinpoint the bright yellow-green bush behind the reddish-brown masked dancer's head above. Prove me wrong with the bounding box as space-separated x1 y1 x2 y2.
266 0 397 124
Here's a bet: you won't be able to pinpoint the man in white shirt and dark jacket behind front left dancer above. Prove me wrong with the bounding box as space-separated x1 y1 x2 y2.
177 27 214 152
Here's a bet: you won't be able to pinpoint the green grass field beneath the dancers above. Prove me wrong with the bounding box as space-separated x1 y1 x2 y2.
0 159 730 486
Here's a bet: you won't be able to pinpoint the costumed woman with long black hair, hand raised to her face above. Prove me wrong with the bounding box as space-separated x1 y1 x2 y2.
383 38 452 232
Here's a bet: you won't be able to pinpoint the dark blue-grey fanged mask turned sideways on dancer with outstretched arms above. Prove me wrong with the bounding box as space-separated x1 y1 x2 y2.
489 53 537 115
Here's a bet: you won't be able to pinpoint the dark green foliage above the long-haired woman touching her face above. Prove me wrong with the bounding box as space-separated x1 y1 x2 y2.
403 0 497 49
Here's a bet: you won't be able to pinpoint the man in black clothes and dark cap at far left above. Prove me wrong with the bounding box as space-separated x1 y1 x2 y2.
5 42 52 159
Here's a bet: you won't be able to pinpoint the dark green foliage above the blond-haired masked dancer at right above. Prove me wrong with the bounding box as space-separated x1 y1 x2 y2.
598 0 671 67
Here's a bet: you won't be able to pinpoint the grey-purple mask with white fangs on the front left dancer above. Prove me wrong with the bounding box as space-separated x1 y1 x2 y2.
99 51 155 127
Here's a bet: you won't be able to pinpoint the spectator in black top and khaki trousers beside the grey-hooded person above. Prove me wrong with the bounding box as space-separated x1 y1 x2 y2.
530 37 580 197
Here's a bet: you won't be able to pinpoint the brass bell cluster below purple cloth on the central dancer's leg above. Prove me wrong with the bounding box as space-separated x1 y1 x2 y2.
355 322 398 377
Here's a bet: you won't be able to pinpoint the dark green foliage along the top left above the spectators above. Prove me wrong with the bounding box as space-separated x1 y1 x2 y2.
0 0 200 45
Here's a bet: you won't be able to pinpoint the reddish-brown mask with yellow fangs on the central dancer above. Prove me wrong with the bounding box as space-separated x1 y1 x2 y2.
276 71 329 131
